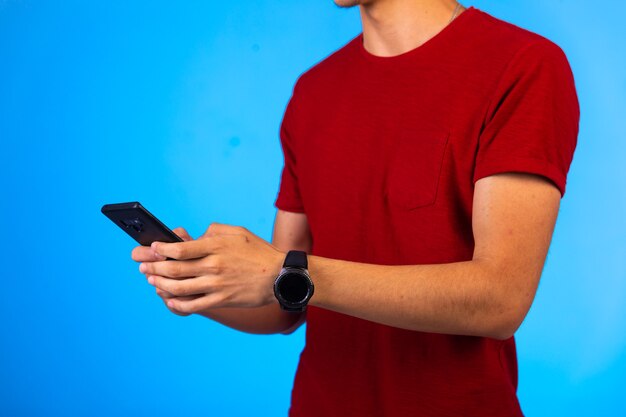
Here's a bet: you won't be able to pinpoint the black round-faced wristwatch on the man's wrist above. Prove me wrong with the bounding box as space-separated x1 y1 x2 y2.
274 250 313 313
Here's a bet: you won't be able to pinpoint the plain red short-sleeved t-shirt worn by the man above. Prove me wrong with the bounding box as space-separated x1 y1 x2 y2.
275 8 579 417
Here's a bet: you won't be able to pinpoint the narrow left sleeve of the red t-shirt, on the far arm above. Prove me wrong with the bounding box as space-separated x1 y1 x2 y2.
274 83 304 213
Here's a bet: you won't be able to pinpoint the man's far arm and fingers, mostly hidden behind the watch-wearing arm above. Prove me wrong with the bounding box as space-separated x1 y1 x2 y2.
133 210 312 334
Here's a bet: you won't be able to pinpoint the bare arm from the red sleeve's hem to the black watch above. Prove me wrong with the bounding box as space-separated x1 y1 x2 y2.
309 173 561 339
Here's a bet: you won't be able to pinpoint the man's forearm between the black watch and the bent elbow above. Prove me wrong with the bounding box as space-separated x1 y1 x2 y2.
309 256 534 339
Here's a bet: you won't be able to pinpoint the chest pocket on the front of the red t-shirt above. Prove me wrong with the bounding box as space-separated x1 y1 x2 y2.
386 130 449 210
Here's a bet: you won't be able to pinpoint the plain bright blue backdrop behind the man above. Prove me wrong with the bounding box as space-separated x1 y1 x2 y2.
0 0 626 416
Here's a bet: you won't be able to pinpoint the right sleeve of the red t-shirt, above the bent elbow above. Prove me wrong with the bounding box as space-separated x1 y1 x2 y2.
473 39 580 197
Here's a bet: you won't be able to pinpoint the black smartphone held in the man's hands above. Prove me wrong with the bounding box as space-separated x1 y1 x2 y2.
101 201 183 246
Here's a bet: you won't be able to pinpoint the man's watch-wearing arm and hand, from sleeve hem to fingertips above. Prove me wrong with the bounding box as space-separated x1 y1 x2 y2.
140 173 561 339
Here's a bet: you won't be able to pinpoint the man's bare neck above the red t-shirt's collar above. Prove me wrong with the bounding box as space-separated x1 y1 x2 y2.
359 0 464 56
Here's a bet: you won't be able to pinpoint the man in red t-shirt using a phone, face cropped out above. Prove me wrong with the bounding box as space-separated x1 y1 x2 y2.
133 0 579 417
